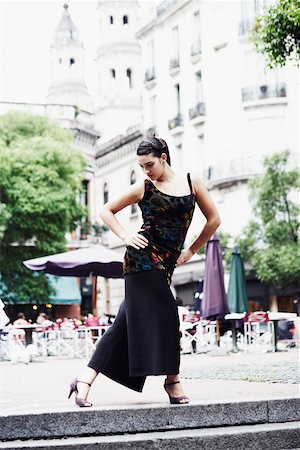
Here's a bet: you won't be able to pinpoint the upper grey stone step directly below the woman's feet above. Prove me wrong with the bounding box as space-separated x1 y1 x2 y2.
0 398 300 441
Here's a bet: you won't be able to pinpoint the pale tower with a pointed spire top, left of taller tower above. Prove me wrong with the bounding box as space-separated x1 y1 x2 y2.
48 4 91 111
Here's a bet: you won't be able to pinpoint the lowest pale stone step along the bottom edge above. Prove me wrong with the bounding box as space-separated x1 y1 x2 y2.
0 422 300 450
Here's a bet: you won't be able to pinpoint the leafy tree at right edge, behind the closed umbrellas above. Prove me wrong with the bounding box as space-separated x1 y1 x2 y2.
238 151 300 288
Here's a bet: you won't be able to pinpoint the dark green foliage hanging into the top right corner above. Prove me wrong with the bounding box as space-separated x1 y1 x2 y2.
251 0 300 68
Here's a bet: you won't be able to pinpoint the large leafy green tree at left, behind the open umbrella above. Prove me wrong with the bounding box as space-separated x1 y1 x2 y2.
0 113 85 303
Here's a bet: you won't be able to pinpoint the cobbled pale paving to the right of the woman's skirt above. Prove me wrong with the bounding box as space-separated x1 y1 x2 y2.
181 349 300 384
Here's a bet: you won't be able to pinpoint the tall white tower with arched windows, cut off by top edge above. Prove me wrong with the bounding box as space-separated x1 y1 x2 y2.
95 0 142 141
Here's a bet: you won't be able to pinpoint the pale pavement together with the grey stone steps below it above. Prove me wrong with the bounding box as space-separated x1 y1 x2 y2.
0 350 300 450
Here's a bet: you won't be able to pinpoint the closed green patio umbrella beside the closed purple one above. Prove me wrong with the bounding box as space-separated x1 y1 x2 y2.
227 245 248 313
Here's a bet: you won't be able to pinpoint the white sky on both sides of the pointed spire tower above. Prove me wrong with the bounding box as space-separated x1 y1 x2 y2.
0 0 98 103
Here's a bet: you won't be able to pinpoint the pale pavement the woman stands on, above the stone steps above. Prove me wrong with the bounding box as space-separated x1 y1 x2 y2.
0 349 299 415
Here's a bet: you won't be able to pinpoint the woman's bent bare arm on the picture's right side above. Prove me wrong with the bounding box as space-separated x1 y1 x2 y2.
176 178 221 267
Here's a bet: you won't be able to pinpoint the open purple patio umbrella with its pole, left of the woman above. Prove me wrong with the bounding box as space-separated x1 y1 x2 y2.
23 245 123 312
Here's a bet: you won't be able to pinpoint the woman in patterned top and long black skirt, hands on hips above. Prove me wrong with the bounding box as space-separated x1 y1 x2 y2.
69 136 220 407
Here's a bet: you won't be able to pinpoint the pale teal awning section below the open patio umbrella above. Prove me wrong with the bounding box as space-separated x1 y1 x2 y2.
47 275 81 305
